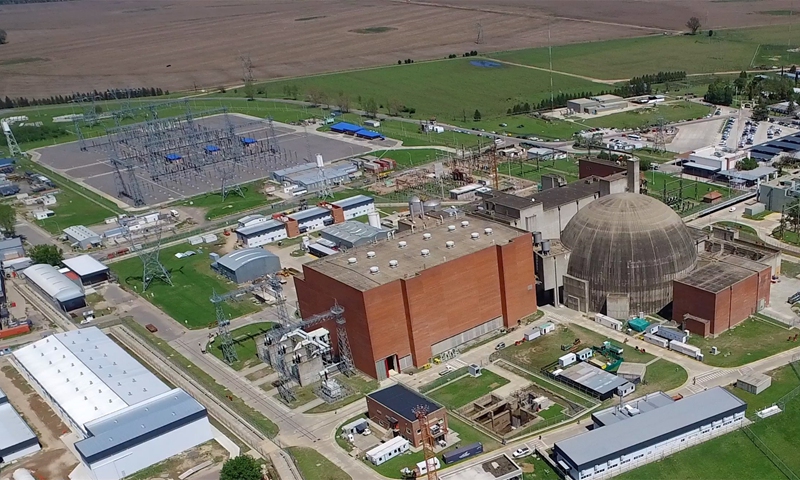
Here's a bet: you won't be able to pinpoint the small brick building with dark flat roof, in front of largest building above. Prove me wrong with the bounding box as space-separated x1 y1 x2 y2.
367 383 447 448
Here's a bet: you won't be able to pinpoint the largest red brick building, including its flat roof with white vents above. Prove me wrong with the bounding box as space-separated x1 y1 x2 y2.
295 217 536 380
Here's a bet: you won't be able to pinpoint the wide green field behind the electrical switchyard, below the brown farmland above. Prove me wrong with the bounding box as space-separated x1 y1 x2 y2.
247 57 608 125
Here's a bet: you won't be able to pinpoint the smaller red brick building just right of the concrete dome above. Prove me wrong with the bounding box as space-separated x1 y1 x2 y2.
672 256 771 337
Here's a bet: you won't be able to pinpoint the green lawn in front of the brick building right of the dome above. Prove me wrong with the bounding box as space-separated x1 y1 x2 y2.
689 317 797 367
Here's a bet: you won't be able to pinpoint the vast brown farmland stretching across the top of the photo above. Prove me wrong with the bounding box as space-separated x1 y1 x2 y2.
0 0 797 97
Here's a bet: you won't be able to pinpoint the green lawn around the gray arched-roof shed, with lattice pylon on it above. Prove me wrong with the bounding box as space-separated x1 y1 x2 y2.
109 243 258 328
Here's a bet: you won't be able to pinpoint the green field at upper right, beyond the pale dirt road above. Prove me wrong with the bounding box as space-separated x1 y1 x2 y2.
488 26 800 80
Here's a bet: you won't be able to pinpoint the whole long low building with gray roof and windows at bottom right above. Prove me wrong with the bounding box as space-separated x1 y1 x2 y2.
553 387 747 480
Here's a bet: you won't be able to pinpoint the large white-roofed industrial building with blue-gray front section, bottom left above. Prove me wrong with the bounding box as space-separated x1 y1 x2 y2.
12 327 212 480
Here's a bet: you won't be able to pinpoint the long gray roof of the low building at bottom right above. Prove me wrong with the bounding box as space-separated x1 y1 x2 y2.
553 387 747 471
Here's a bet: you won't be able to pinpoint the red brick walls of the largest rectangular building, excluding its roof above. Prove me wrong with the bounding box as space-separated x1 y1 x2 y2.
295 234 537 377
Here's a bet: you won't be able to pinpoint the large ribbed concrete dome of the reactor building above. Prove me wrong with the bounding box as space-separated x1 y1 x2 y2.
561 193 697 315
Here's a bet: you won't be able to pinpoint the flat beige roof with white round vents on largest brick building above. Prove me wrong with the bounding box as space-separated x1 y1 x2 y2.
303 216 530 291
